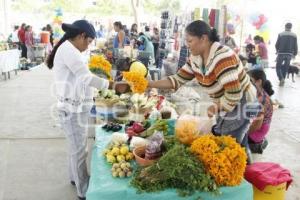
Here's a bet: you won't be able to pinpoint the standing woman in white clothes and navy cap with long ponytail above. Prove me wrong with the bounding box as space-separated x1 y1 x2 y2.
46 20 119 199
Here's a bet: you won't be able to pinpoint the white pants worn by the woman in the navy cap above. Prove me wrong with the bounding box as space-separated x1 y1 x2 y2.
59 111 89 197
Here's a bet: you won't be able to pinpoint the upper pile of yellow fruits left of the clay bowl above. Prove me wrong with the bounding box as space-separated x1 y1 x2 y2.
103 142 134 164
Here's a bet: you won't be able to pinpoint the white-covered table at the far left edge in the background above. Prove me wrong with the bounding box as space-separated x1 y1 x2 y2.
0 49 20 80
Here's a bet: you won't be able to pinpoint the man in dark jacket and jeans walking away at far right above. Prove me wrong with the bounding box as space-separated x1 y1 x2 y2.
275 23 298 86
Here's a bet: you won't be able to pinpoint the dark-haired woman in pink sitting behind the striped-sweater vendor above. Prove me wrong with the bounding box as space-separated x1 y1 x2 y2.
248 69 274 153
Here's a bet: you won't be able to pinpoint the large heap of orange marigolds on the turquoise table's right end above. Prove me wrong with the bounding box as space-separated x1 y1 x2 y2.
191 134 247 186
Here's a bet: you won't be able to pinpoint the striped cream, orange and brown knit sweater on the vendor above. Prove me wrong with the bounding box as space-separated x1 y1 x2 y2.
168 42 256 112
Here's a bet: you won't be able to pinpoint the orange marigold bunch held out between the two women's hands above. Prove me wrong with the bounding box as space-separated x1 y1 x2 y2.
123 70 148 94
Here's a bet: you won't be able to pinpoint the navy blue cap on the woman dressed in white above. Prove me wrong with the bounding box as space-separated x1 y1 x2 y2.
62 19 96 38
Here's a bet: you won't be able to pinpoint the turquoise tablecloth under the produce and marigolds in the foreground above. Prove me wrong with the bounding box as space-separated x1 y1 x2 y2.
86 126 253 200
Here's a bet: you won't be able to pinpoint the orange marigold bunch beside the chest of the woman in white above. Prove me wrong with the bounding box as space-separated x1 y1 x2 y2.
89 55 112 80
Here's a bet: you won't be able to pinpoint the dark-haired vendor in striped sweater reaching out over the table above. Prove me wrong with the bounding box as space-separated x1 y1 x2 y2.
149 20 257 161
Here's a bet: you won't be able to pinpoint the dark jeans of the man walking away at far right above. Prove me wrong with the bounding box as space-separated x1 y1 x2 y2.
276 54 292 81
